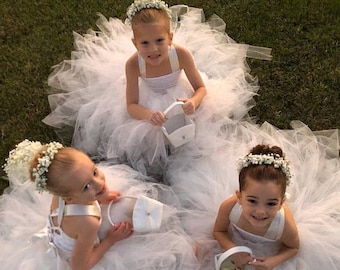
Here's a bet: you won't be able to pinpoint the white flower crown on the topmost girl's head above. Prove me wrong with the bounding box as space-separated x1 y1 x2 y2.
126 0 171 24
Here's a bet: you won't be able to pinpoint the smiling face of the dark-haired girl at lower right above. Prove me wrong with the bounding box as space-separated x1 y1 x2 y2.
237 177 284 231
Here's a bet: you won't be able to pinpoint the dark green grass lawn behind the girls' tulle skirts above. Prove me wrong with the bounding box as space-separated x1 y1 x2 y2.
0 0 340 192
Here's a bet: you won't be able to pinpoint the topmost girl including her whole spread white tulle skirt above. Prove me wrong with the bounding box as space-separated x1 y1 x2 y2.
43 0 268 178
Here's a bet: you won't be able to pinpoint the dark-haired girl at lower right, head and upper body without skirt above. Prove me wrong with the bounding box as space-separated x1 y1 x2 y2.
214 145 299 270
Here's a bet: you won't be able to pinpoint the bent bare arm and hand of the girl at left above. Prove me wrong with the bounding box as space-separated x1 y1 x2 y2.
70 216 132 270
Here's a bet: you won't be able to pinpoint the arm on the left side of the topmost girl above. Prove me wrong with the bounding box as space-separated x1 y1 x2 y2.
125 53 166 125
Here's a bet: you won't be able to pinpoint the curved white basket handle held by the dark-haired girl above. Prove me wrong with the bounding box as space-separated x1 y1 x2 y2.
215 246 253 270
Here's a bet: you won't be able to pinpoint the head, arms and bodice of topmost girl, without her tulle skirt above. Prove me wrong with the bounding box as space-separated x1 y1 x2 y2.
126 0 206 126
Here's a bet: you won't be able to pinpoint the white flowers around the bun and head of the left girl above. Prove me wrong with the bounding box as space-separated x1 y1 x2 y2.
3 139 63 192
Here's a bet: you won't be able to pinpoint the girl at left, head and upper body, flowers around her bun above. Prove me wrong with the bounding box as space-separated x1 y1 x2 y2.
5 140 133 269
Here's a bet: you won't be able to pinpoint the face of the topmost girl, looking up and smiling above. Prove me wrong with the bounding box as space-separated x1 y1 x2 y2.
132 21 173 66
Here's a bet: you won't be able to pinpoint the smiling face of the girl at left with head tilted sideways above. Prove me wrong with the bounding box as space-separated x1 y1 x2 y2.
62 152 109 204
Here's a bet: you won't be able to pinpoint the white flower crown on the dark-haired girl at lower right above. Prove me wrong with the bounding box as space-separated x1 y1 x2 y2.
238 153 292 186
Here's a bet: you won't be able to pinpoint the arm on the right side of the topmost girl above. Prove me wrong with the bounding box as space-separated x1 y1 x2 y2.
174 45 207 114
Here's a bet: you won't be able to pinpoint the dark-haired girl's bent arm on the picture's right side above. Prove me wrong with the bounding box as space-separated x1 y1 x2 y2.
250 205 300 269
